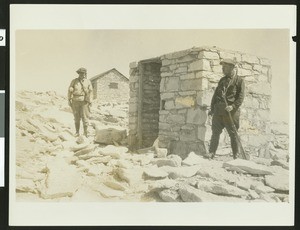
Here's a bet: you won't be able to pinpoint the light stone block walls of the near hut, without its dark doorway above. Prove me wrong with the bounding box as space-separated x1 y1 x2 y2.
129 47 271 157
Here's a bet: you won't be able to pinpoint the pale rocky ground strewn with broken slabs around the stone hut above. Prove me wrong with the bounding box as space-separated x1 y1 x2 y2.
16 91 289 202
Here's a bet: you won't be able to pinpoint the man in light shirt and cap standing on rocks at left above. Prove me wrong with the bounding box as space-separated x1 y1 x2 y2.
68 68 93 137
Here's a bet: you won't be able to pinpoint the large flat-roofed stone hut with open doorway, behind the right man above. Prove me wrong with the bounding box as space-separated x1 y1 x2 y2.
129 47 272 157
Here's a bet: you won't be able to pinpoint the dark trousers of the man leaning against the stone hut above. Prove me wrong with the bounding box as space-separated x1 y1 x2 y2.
209 110 240 157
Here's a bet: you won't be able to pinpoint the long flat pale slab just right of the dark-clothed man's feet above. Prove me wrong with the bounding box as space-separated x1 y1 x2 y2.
223 159 272 175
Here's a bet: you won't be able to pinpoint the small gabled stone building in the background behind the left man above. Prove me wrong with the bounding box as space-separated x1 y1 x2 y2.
90 68 129 102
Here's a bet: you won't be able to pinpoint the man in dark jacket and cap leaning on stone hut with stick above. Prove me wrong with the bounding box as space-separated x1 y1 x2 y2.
205 59 245 159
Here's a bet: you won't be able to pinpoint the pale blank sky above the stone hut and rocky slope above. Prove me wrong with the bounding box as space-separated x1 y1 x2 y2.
15 29 290 121
